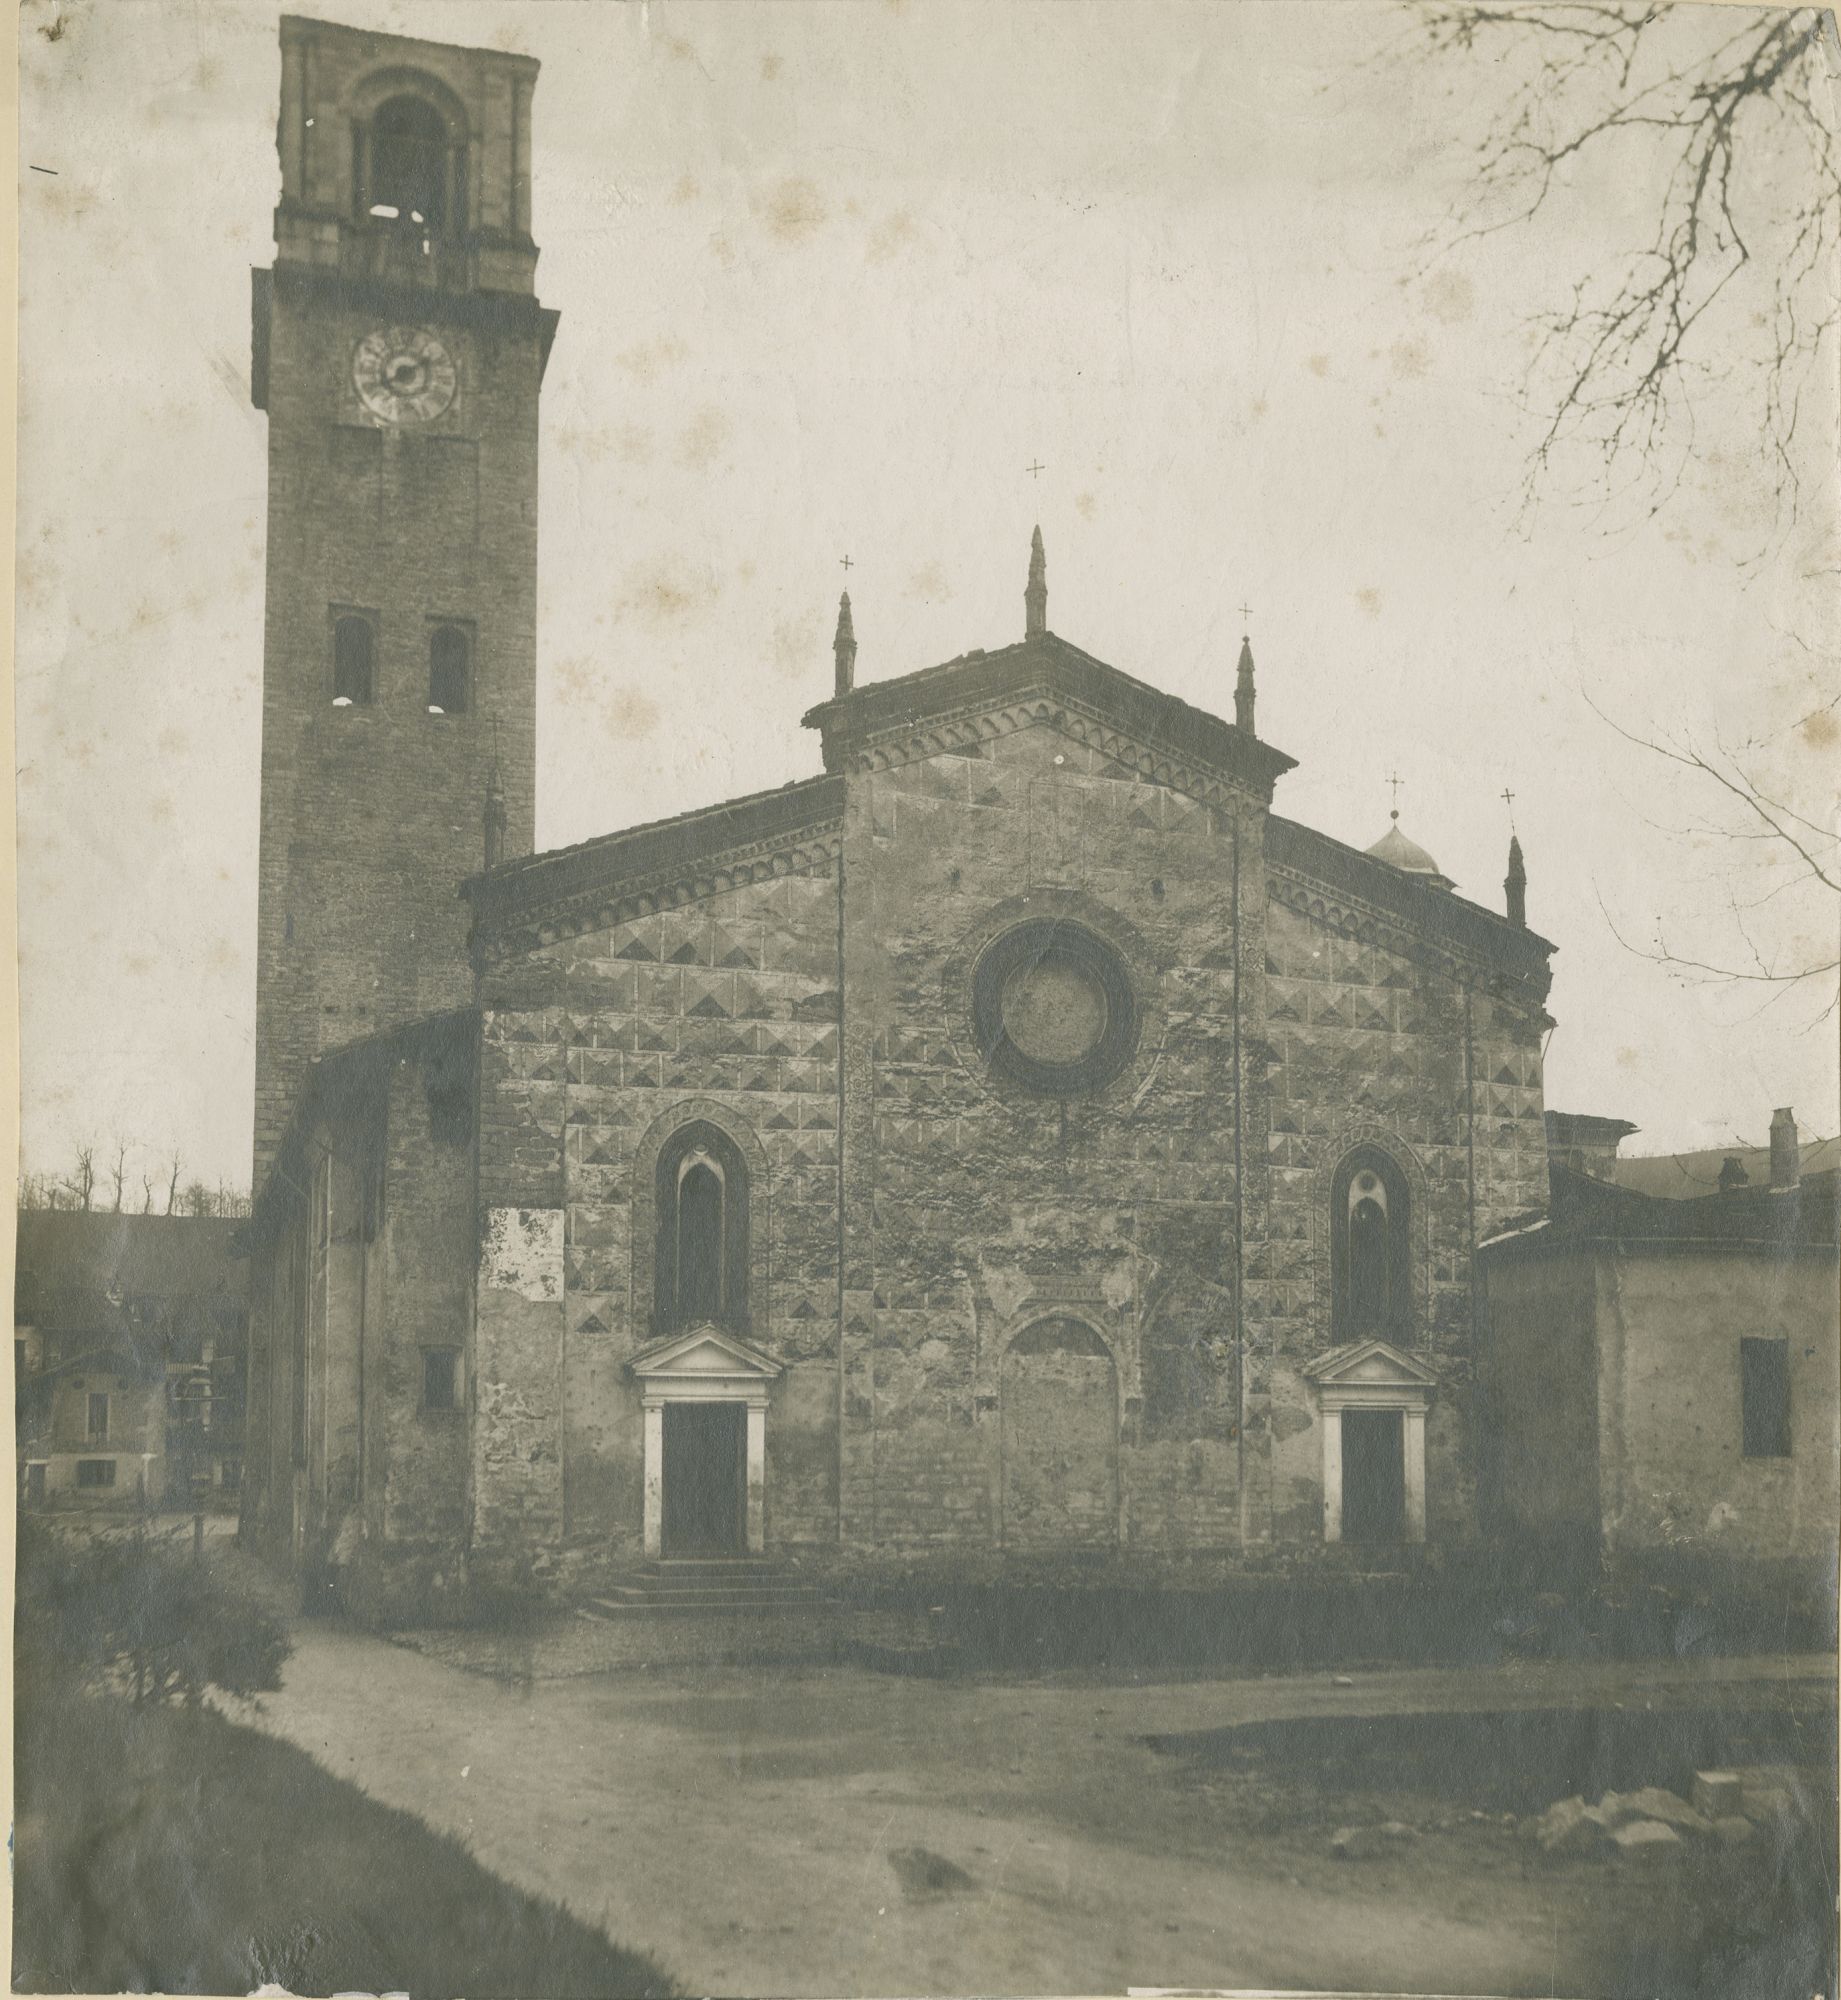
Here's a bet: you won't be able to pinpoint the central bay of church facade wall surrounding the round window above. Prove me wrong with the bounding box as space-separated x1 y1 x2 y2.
842 722 1259 1550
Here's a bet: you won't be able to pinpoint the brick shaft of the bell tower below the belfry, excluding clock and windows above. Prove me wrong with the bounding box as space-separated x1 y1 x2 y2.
256 284 540 1186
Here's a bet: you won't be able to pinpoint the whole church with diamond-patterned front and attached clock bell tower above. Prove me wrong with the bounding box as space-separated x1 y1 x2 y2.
246 22 1553 1610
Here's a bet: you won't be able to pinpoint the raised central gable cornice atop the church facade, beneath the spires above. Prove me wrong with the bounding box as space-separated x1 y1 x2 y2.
804 632 1297 800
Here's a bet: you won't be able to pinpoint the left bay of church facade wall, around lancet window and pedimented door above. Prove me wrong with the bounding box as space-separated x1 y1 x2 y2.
476 864 838 1556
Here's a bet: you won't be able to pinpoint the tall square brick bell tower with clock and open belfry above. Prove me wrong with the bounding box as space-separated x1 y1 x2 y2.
250 16 556 1188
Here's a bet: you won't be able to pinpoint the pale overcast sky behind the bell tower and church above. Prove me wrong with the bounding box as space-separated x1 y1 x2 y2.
18 0 1837 1206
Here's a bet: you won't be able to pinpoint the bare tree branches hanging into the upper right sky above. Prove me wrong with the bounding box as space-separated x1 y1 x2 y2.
1401 0 1841 532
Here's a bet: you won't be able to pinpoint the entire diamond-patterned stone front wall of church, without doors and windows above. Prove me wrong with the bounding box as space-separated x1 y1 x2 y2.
258 600 1547 1600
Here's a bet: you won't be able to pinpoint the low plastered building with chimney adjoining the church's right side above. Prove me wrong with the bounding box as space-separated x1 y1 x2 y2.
1481 1110 1841 1560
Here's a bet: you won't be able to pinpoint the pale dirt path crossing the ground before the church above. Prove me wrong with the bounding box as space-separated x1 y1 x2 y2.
237 1626 1833 1996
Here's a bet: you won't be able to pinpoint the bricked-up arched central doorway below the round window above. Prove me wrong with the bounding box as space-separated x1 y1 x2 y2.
999 1318 1119 1550
